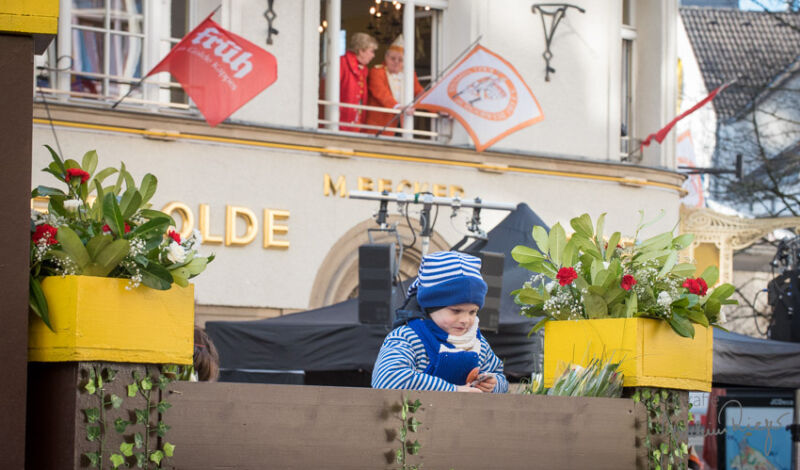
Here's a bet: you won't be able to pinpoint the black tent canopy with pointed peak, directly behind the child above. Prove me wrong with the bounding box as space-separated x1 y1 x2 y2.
206 204 546 376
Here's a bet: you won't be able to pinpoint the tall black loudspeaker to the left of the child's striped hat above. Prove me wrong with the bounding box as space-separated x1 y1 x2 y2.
358 243 395 325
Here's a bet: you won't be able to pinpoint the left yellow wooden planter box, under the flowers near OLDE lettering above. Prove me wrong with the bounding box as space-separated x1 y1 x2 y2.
28 276 194 364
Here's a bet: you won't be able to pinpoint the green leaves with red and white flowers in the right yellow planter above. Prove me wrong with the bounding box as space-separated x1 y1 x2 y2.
511 212 736 337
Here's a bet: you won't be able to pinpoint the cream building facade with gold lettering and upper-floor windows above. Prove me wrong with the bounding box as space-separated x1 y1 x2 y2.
33 0 683 323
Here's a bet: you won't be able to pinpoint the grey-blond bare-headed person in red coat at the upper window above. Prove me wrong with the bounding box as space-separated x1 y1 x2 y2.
339 33 378 132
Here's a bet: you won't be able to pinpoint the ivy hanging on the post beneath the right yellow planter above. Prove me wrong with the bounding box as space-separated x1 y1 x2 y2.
632 388 692 470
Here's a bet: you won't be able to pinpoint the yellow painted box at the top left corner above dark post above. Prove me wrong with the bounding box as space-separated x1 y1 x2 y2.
0 0 58 34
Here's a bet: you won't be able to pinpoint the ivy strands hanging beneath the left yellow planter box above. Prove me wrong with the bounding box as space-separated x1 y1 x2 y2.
83 366 180 469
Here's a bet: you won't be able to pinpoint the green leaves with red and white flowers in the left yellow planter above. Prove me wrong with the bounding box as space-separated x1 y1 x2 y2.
29 146 214 330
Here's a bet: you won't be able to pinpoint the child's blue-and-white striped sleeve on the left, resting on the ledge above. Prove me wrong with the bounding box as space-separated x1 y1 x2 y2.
372 326 456 392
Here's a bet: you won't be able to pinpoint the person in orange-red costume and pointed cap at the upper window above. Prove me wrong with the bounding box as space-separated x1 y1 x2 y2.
363 34 422 135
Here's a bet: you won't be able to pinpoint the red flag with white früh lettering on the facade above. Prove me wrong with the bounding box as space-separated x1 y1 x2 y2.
145 13 278 127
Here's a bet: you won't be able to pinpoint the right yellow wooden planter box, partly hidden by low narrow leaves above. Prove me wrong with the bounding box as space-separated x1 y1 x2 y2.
544 318 714 392
